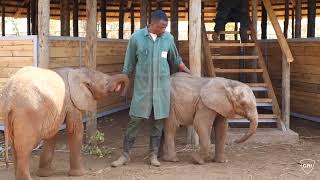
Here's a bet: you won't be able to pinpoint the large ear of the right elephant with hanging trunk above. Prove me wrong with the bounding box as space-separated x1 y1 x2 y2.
200 78 235 118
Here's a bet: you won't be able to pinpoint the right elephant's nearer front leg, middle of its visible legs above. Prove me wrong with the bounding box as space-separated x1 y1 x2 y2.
192 107 216 164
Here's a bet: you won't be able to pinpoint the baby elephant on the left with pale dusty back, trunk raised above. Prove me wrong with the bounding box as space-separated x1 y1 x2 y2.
0 67 129 180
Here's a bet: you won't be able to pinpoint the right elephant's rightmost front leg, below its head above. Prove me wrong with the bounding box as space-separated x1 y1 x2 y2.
213 116 228 163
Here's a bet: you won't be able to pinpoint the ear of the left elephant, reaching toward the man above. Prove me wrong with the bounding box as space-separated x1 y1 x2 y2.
68 69 97 112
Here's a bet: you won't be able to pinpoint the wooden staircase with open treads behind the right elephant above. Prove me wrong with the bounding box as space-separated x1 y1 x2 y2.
202 24 286 131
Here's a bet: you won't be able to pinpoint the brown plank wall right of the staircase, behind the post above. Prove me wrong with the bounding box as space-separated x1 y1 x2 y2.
261 40 320 116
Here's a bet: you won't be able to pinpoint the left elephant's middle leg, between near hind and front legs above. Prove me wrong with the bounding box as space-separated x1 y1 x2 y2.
37 135 57 177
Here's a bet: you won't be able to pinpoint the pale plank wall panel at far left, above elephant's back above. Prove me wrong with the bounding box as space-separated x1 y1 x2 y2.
0 38 34 89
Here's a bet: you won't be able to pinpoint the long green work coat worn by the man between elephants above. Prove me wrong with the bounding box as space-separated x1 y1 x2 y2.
123 27 182 119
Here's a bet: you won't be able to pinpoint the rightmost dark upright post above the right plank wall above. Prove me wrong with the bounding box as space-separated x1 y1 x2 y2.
307 0 317 37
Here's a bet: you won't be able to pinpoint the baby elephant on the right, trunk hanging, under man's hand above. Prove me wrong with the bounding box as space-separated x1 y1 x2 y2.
163 73 258 164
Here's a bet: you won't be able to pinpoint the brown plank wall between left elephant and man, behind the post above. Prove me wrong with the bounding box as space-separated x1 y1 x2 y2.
49 38 131 112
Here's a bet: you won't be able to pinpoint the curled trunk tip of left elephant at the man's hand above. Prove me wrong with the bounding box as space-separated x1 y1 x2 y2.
108 74 129 96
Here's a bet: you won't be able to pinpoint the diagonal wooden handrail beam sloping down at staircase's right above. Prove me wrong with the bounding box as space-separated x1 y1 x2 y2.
263 0 293 62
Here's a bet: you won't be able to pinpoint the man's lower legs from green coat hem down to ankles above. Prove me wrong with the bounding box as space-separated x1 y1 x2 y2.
123 116 164 157
